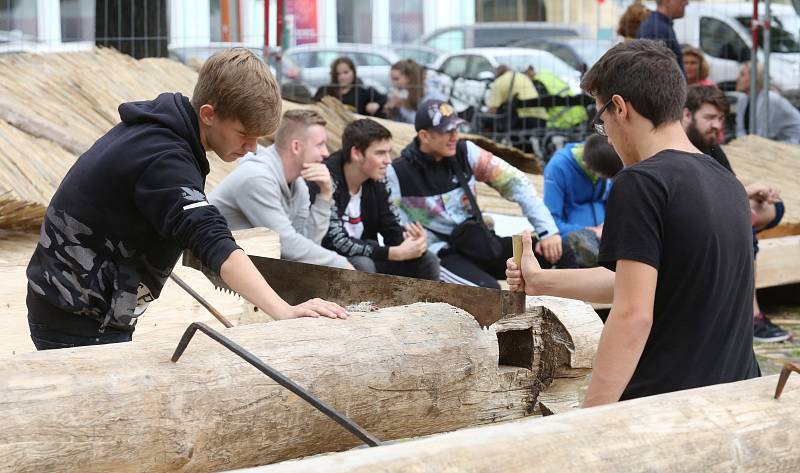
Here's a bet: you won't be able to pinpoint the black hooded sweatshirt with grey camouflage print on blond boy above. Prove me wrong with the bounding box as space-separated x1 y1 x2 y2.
27 93 238 331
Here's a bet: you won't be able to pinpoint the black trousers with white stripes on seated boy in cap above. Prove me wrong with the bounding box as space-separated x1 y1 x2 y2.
439 233 577 289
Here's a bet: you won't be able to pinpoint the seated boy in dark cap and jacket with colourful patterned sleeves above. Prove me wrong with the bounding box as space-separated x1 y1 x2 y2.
388 100 575 288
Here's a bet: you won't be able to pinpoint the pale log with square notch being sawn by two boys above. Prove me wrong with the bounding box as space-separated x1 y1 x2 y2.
0 300 599 472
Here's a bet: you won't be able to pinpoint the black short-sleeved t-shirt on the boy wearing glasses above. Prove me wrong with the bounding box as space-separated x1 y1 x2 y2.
598 150 760 400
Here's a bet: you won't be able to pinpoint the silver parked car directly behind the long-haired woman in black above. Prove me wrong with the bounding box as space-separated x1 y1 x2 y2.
283 43 400 95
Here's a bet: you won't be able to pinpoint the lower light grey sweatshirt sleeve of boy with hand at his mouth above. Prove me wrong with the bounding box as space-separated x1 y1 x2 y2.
236 175 347 268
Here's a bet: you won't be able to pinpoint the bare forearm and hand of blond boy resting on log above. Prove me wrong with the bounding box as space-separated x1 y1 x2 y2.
220 250 349 320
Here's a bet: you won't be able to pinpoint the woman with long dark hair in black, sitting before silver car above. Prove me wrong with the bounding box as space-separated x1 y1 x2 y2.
314 57 386 115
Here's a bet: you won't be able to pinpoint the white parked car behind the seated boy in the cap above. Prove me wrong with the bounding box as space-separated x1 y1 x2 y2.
433 48 581 111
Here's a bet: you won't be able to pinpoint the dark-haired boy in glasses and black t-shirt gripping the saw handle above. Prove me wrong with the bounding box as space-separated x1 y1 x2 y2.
507 40 760 407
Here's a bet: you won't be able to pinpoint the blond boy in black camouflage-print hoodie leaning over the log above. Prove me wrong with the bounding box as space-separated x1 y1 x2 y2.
27 48 346 350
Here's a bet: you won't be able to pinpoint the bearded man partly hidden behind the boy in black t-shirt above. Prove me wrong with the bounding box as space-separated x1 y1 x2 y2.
683 86 792 342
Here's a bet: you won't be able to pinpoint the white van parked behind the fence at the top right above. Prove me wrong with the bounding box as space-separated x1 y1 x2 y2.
664 2 800 92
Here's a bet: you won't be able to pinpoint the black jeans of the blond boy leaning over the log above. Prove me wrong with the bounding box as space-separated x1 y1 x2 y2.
25 286 133 350
